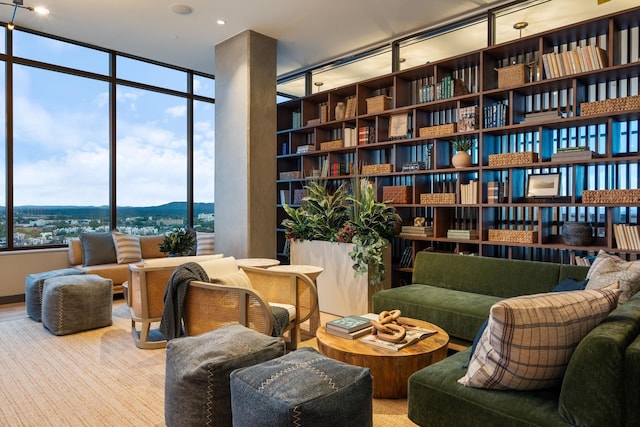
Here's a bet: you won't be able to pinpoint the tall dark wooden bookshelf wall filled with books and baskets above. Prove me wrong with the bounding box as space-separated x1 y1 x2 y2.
276 8 640 280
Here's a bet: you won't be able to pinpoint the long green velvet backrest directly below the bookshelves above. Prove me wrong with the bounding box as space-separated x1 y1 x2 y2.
412 252 564 300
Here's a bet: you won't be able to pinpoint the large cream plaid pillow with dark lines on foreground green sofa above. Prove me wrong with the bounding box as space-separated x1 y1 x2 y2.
458 286 620 390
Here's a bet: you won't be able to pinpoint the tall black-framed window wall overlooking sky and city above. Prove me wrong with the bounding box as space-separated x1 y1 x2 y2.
0 27 215 249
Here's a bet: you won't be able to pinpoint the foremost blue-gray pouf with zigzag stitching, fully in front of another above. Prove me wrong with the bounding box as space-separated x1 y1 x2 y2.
230 347 373 427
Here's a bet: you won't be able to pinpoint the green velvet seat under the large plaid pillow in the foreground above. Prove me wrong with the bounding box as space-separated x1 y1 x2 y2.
408 350 567 427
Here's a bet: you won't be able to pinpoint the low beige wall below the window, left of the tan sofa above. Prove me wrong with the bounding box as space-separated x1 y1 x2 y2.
0 248 69 303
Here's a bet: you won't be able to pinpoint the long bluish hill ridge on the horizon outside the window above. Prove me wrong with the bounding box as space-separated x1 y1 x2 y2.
5 202 215 218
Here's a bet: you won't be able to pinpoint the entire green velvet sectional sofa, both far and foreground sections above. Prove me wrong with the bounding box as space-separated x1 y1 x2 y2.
374 252 640 427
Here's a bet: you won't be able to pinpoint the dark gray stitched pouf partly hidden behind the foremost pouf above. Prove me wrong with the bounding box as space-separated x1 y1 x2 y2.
164 324 285 427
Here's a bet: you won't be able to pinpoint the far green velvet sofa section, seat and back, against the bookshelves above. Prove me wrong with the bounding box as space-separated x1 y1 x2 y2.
373 252 589 349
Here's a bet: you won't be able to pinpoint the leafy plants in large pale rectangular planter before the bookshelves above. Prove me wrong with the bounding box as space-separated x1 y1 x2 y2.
282 179 401 315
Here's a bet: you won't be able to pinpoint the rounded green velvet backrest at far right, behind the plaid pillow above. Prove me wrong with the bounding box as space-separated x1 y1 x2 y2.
559 294 640 426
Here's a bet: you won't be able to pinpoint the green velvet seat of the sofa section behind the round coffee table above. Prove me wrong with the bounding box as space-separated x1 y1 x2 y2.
373 285 502 342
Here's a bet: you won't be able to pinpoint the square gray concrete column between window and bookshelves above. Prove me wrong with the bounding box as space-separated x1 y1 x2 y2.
215 30 276 258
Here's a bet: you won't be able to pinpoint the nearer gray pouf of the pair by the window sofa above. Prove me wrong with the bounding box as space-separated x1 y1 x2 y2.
42 274 113 335
